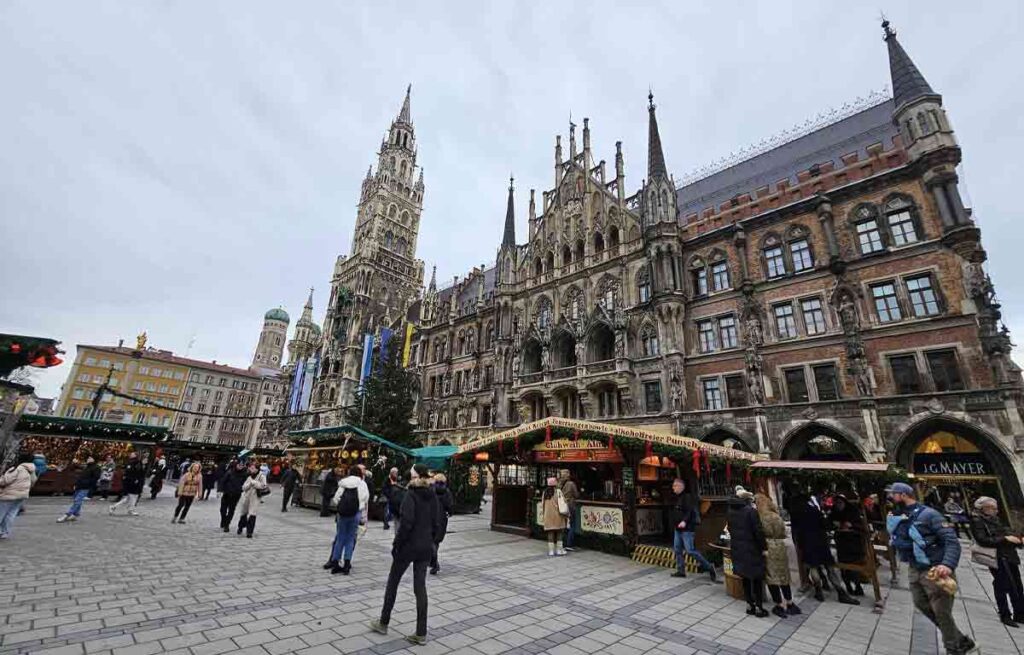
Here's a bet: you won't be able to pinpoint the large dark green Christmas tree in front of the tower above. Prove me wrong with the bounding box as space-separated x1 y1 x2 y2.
345 335 420 448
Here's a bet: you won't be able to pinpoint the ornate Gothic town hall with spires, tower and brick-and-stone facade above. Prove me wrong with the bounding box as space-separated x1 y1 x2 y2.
312 24 1024 507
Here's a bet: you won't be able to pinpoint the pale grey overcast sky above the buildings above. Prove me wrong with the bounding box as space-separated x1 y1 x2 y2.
0 0 1024 395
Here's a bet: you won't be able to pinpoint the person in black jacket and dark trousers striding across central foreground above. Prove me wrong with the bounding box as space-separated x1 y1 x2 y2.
370 464 438 646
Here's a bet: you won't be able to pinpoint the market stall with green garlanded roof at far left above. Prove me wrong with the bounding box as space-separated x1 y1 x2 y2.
14 414 170 495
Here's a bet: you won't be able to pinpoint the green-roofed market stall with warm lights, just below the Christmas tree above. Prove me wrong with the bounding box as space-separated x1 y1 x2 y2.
285 425 414 519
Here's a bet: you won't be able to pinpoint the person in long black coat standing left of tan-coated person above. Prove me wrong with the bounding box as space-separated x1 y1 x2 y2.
728 486 768 617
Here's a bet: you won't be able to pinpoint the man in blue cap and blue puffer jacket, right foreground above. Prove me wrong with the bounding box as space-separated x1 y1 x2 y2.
886 482 975 655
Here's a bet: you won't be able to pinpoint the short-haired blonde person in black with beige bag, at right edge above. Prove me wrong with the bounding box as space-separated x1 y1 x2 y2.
971 495 1024 627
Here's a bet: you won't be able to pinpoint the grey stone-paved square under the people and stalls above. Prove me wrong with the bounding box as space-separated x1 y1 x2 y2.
0 489 1024 655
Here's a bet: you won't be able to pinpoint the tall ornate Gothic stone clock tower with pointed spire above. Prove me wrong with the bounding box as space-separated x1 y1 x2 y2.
310 85 424 413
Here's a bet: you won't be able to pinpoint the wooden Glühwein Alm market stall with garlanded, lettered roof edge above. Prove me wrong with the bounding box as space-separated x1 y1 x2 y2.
457 417 758 563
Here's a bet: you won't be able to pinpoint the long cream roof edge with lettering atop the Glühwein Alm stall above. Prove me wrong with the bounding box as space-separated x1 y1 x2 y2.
458 417 764 462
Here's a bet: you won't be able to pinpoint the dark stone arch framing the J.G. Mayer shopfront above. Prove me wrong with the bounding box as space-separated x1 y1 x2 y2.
892 411 1024 508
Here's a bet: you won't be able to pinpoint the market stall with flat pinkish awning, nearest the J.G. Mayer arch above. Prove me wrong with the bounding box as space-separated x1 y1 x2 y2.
751 461 910 611
